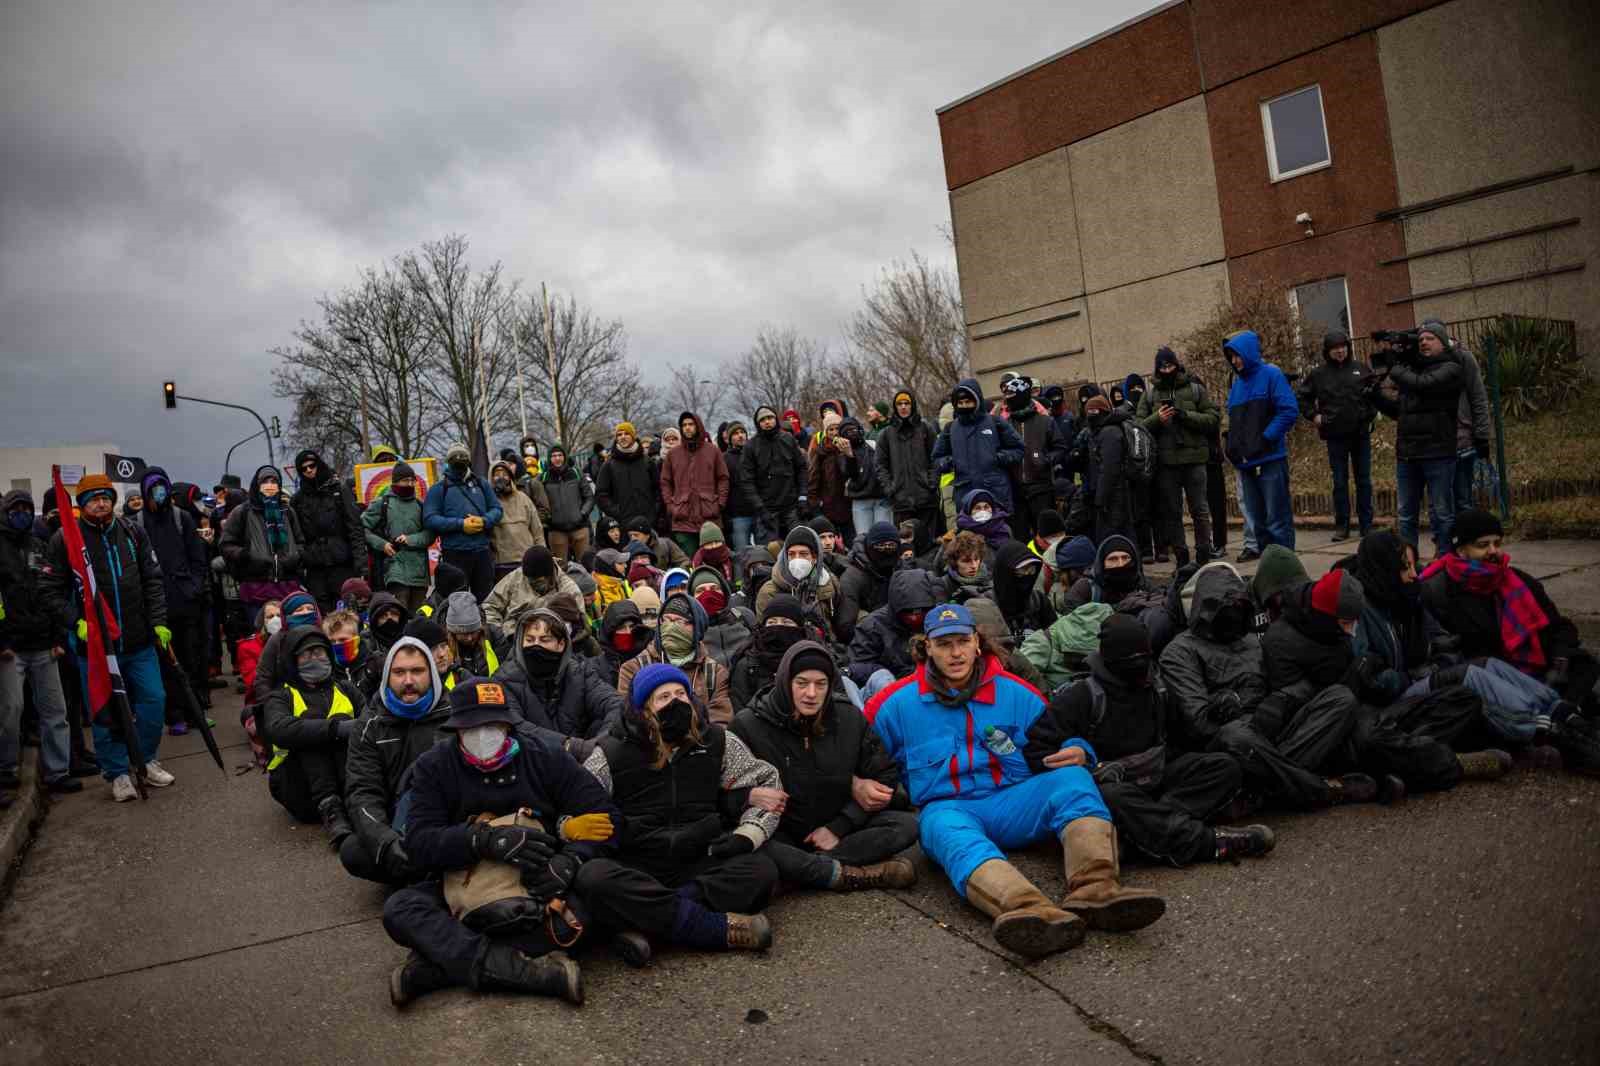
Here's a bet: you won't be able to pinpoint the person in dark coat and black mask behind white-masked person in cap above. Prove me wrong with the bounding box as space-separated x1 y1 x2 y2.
491 607 622 762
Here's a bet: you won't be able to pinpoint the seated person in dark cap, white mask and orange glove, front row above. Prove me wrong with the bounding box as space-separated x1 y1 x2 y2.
384 680 616 1007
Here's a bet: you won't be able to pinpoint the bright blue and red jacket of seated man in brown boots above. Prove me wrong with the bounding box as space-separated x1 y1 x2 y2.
866 655 1094 807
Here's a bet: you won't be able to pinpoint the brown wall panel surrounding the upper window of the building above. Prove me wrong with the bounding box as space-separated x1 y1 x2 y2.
1206 34 1398 256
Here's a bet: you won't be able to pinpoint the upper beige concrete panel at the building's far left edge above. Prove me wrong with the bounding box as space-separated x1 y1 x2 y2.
950 149 1083 322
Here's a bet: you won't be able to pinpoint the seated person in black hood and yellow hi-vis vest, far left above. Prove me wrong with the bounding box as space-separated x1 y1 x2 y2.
259 626 362 850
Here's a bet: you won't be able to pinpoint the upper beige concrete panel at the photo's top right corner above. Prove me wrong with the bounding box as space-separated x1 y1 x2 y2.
1376 0 1600 203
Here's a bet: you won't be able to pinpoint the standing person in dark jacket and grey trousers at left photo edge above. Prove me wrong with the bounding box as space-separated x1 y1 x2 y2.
0 488 83 797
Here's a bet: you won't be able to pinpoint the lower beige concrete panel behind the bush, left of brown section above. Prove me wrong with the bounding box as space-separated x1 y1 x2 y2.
1090 262 1227 381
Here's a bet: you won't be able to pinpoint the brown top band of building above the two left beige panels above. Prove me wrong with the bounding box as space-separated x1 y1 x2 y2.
939 5 1200 189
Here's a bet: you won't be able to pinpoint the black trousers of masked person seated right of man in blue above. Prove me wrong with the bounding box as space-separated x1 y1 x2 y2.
1099 752 1245 866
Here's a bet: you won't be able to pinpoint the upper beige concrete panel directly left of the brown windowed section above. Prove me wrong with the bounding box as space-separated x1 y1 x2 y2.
1067 96 1224 293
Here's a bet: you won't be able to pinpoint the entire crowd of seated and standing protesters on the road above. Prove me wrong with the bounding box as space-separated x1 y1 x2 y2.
0 316 1600 1005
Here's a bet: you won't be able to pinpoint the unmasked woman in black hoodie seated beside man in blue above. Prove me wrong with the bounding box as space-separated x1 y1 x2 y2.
730 640 917 892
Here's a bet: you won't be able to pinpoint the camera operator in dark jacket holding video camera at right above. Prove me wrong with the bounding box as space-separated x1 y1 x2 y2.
1368 319 1462 555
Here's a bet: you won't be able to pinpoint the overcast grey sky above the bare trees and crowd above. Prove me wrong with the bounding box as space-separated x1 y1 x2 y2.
0 0 1149 483
